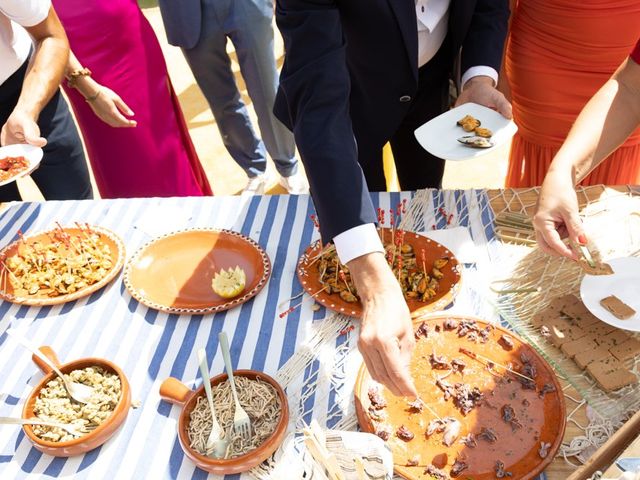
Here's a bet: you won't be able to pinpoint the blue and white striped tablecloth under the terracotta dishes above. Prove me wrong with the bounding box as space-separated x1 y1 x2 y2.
0 191 548 480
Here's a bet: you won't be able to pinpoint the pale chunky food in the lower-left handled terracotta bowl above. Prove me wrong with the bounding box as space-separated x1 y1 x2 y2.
31 366 122 442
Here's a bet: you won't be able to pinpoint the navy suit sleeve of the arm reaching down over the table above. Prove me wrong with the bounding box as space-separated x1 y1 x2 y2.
274 0 375 242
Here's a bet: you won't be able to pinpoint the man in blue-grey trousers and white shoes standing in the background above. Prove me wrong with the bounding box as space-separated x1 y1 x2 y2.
159 0 308 193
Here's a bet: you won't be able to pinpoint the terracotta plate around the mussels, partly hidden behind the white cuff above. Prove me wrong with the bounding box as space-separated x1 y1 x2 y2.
297 228 461 317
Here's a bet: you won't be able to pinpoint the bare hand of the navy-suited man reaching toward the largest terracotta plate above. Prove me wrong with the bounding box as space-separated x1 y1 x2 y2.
348 253 417 397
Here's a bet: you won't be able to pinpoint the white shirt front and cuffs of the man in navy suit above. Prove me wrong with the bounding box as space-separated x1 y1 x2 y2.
333 0 498 264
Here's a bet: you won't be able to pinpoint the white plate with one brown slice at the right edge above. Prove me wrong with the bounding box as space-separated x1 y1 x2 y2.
580 257 640 332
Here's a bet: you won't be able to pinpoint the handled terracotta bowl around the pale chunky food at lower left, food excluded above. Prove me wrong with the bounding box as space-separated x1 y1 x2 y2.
22 347 131 457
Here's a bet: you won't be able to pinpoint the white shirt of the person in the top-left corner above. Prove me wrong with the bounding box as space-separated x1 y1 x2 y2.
0 0 51 85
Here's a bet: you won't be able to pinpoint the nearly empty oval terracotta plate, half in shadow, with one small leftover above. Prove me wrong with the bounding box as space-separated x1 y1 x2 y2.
124 229 271 314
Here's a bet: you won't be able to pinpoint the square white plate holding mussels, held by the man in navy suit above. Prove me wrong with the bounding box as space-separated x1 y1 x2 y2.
415 103 518 161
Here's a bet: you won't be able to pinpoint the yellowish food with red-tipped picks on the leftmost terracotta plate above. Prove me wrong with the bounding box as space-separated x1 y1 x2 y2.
0 226 114 297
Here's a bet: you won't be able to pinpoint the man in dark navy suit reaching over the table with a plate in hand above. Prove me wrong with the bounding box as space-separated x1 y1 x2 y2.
275 0 511 395
